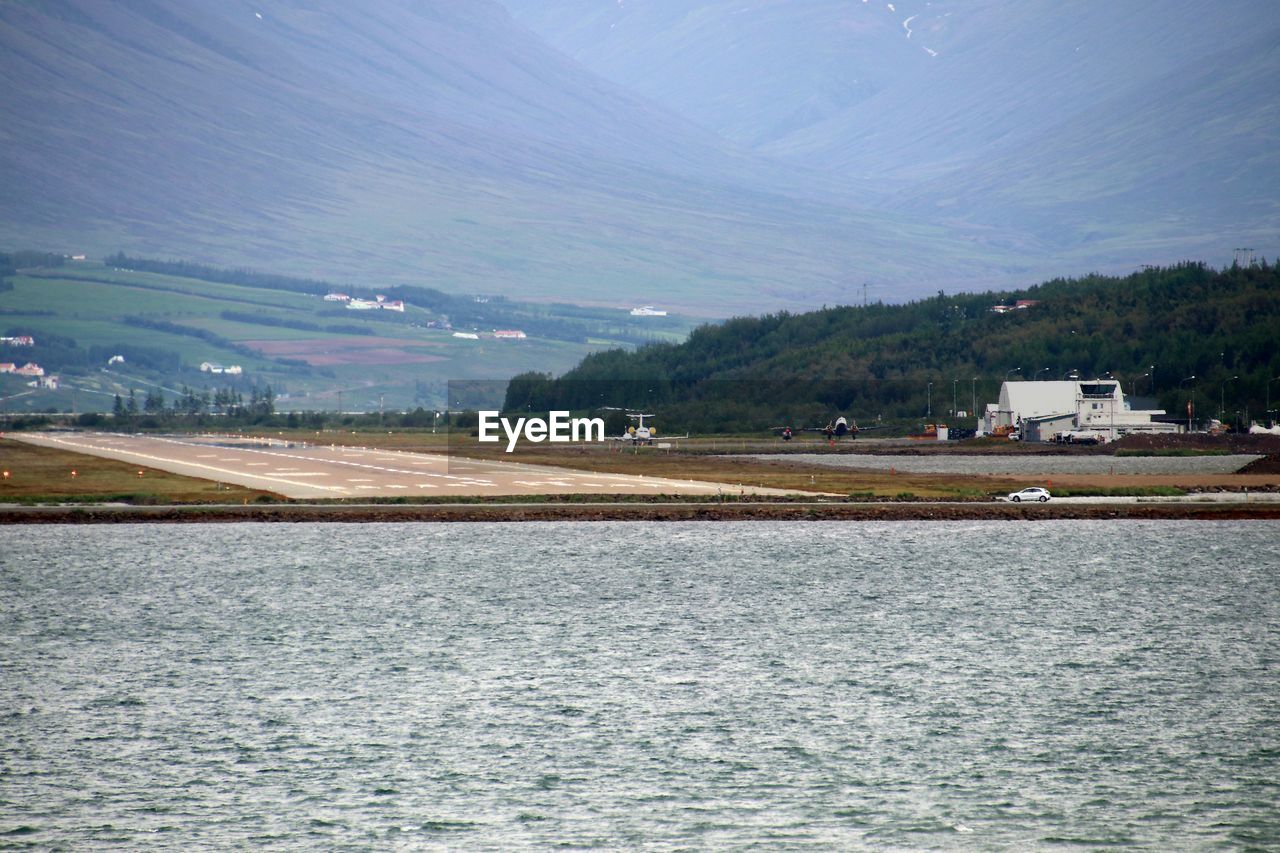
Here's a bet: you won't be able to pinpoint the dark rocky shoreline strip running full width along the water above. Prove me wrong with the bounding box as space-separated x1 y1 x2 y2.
0 501 1280 525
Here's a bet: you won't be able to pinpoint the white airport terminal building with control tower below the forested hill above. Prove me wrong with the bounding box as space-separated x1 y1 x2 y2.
978 379 1183 442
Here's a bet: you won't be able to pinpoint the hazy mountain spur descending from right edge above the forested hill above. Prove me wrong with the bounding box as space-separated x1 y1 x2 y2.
901 27 1280 258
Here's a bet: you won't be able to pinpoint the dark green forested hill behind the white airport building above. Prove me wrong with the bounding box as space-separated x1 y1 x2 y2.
507 260 1280 429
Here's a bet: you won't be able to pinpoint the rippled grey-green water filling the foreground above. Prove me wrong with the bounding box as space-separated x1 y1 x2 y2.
0 521 1280 849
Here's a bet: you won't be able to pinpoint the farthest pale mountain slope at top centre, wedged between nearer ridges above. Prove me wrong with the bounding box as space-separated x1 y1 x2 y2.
503 0 928 145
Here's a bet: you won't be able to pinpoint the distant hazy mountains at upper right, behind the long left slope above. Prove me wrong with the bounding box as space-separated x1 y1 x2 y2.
504 0 1280 269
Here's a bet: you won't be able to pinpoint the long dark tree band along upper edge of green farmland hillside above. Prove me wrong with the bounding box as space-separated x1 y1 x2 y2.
104 252 680 345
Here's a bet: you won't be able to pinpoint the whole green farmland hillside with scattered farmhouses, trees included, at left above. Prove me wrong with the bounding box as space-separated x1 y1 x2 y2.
0 252 690 412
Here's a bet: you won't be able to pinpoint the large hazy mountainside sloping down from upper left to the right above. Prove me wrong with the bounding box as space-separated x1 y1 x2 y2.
0 0 1023 314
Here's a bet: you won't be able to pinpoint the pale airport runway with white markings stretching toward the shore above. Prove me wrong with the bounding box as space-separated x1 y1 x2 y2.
17 433 788 500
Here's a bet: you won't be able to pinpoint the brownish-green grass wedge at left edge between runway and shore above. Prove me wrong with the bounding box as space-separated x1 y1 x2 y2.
0 438 268 503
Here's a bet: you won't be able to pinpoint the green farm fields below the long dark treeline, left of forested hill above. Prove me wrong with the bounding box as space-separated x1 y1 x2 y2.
0 263 665 411
